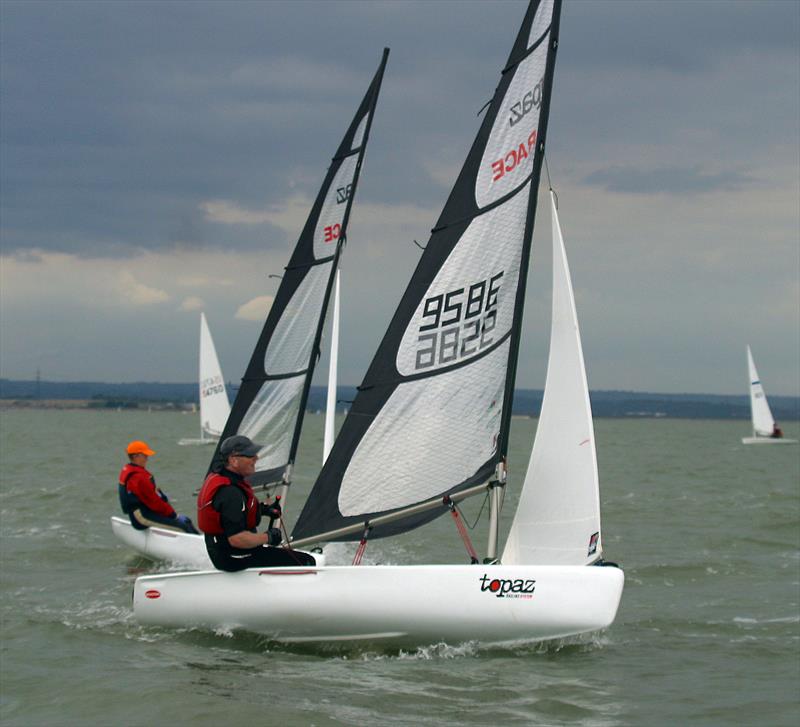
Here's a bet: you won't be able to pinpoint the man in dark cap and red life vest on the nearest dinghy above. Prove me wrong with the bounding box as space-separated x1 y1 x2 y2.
197 435 316 571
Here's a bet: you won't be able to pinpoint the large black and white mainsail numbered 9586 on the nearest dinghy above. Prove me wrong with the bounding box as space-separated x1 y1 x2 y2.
292 0 560 540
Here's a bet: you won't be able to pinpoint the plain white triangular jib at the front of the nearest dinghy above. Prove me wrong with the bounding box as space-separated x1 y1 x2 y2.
502 192 601 565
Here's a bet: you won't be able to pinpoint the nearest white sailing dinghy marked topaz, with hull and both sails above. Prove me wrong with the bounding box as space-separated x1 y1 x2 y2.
133 0 624 644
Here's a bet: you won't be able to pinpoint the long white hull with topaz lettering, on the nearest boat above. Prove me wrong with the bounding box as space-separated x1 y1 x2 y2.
133 565 625 644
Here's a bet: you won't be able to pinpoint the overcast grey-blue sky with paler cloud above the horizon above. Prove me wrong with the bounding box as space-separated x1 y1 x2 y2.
0 0 800 395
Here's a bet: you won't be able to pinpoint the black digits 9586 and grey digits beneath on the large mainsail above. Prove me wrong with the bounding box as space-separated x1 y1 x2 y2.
415 272 503 370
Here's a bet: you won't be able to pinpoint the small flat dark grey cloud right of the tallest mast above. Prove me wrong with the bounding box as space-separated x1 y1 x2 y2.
584 167 754 195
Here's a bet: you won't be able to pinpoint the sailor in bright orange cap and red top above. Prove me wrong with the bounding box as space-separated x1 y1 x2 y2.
119 439 197 533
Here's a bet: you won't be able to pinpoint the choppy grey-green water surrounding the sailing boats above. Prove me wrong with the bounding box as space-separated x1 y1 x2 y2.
0 411 800 726
